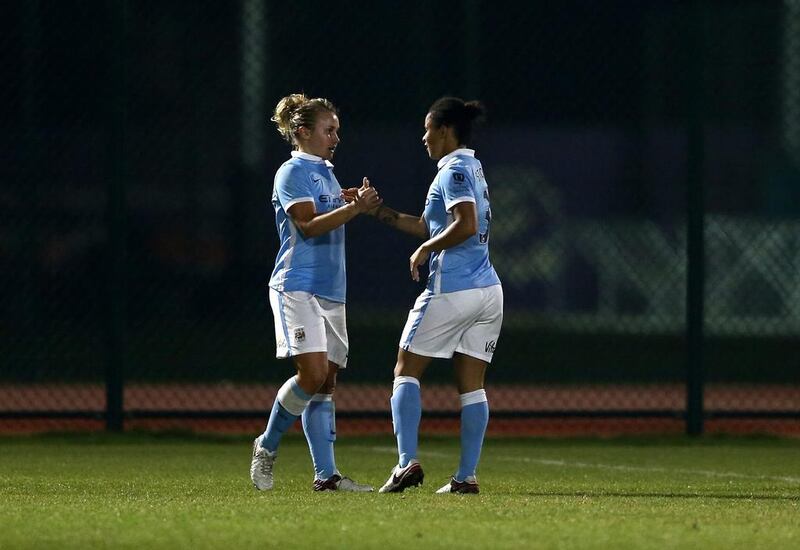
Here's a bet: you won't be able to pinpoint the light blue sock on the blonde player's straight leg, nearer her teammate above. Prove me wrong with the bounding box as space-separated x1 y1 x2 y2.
303 393 336 479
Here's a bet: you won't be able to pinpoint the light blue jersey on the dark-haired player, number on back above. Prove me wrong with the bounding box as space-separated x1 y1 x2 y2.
425 149 500 294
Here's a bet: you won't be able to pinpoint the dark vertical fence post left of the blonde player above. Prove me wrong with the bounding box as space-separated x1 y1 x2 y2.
105 0 127 432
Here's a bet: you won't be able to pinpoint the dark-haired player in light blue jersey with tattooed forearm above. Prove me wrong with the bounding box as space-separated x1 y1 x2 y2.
370 97 503 493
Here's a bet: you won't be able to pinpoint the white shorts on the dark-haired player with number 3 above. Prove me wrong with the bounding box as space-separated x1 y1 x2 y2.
400 285 503 363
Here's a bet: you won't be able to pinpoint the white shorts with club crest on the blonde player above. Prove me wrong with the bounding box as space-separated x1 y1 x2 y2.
269 288 348 369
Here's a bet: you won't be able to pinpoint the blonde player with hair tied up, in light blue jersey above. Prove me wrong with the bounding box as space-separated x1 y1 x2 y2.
250 94 381 491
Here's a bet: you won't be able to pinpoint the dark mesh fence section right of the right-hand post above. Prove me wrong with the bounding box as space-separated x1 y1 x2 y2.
705 1 800 436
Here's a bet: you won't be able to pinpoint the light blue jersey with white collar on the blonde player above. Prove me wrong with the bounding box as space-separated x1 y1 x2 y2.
269 151 347 303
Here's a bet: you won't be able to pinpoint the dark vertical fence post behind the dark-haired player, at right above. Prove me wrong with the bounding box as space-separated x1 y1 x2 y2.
686 0 705 435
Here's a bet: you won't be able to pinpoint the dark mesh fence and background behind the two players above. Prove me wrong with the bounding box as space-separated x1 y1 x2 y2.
0 0 800 433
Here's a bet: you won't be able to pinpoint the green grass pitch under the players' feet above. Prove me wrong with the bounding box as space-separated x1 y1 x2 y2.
0 434 800 550
